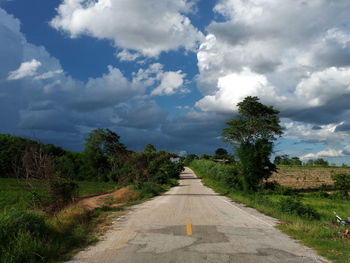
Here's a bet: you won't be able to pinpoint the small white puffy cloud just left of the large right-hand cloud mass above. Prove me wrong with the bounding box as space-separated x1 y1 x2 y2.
151 70 186 96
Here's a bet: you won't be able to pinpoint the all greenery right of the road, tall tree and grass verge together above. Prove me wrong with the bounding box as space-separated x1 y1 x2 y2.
189 97 350 263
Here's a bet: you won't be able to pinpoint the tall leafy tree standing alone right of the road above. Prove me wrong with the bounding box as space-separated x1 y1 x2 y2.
222 97 283 191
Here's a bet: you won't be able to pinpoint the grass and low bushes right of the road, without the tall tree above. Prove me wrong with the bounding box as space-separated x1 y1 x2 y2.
190 160 350 263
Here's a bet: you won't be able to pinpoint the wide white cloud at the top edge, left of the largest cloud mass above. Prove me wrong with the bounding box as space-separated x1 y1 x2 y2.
50 0 202 57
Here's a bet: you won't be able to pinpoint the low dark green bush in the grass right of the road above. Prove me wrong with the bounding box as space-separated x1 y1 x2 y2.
278 197 321 220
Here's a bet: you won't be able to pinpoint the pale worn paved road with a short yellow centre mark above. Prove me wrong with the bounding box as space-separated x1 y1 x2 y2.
70 168 327 263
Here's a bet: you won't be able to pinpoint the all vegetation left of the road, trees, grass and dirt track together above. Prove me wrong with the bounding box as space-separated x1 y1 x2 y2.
0 129 183 263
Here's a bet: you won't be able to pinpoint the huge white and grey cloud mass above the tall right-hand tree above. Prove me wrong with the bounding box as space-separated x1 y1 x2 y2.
196 0 350 124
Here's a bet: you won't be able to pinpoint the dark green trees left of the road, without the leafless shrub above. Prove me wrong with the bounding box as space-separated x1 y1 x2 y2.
0 129 181 184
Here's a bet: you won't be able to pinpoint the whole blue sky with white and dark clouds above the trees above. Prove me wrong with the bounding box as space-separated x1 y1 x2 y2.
0 0 350 164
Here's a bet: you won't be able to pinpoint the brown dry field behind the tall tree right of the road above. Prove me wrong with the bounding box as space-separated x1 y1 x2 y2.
269 166 350 189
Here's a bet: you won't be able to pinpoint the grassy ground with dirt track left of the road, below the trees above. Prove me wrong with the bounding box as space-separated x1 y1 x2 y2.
0 178 177 263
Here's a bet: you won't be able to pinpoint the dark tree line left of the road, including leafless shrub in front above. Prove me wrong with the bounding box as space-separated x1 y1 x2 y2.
0 129 183 212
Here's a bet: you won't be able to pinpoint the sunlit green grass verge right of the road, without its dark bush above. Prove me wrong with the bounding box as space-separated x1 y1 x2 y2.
190 161 350 263
